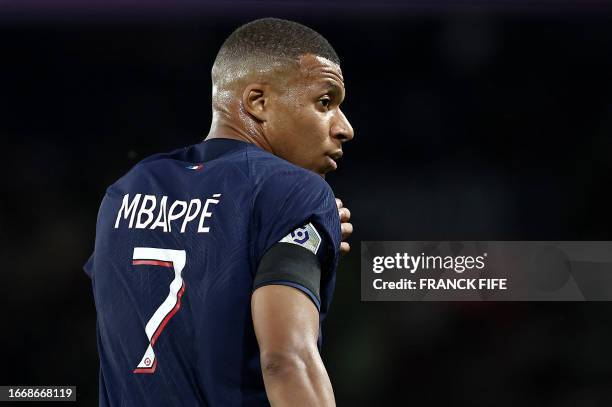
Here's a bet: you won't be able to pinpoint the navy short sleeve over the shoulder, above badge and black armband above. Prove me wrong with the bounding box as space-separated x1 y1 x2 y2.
253 169 341 273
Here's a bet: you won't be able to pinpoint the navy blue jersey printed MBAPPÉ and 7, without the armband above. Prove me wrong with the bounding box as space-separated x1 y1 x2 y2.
85 139 341 406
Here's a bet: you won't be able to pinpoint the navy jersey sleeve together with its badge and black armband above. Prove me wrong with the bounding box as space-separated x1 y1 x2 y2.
253 169 340 312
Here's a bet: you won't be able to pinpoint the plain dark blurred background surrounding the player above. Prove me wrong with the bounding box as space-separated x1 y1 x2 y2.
0 0 612 406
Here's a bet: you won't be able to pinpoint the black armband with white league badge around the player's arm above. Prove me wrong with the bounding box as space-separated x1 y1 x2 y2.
253 224 321 309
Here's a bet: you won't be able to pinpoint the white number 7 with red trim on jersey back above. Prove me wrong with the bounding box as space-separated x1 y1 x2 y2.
132 247 187 373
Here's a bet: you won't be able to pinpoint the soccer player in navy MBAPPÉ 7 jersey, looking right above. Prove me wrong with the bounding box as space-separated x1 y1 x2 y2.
85 18 353 407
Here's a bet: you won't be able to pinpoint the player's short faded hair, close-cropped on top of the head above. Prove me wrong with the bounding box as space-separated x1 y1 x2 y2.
212 17 340 90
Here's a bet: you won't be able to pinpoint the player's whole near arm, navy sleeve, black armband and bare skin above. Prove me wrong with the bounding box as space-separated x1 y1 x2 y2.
251 170 340 406
